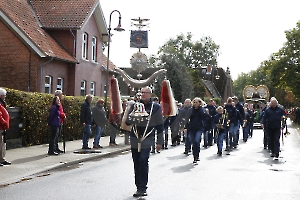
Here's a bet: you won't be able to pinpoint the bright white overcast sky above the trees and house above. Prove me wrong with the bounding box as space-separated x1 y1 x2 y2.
100 0 300 80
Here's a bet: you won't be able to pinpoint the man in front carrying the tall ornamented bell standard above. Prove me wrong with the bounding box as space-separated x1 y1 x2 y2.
126 87 164 197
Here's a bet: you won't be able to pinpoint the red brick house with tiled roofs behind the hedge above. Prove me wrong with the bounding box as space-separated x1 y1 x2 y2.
0 0 115 96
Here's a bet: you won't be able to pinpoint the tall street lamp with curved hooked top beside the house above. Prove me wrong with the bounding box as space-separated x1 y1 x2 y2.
104 10 125 112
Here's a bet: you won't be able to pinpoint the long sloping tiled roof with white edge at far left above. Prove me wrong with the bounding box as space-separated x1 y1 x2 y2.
0 0 78 63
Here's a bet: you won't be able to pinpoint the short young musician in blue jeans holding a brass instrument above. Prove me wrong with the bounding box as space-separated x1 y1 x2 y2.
213 106 226 156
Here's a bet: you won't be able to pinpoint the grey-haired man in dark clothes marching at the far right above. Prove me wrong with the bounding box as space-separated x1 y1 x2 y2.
261 97 285 158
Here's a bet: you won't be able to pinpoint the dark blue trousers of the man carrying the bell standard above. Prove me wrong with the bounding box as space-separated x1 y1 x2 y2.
131 148 150 191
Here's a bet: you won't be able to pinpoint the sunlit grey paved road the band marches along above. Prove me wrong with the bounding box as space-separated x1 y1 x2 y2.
0 119 300 200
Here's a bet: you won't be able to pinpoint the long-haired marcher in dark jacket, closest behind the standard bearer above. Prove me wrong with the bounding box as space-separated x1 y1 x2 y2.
186 97 204 163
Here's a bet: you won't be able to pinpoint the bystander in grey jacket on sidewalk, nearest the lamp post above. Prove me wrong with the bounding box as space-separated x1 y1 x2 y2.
92 99 107 149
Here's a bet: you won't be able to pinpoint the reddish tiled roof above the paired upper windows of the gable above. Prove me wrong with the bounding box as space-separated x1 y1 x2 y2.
30 0 108 41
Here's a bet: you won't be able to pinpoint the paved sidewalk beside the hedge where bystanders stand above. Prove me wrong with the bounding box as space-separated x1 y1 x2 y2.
0 136 130 187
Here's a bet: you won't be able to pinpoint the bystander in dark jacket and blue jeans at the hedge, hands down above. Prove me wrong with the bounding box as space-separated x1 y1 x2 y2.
80 94 94 149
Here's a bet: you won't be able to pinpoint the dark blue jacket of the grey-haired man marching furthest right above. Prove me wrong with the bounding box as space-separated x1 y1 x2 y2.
262 106 286 128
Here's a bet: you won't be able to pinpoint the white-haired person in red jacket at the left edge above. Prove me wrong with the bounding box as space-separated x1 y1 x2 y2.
0 88 11 166
